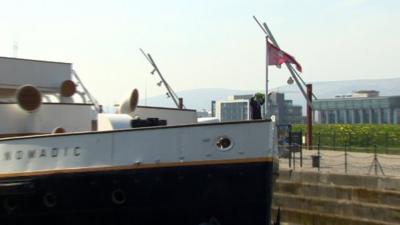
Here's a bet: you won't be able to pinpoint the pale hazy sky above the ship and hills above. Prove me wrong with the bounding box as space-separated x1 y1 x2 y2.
0 0 400 104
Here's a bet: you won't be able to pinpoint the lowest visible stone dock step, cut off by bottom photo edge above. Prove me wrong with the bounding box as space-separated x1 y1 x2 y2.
272 207 398 225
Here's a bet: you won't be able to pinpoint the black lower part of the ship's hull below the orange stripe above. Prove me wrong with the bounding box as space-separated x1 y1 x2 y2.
0 162 272 225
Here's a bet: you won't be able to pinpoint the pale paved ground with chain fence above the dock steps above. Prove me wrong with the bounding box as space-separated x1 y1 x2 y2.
279 150 400 176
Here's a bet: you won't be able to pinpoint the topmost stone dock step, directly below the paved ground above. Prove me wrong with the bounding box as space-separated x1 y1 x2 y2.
279 169 400 191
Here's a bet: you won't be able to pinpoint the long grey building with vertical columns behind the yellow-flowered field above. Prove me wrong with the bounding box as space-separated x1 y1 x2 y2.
313 90 400 124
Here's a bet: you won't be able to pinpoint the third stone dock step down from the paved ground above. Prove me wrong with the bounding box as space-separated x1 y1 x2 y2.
272 192 400 223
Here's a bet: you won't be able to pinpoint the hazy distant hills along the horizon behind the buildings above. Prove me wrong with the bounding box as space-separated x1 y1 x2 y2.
140 78 400 114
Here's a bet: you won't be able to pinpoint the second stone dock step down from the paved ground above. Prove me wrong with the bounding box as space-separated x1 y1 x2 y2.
274 180 400 207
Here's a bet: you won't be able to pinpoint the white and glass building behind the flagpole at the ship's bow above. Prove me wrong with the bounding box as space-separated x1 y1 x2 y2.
211 92 304 124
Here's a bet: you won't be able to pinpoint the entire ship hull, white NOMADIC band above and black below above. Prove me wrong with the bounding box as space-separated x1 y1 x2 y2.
0 121 274 225
